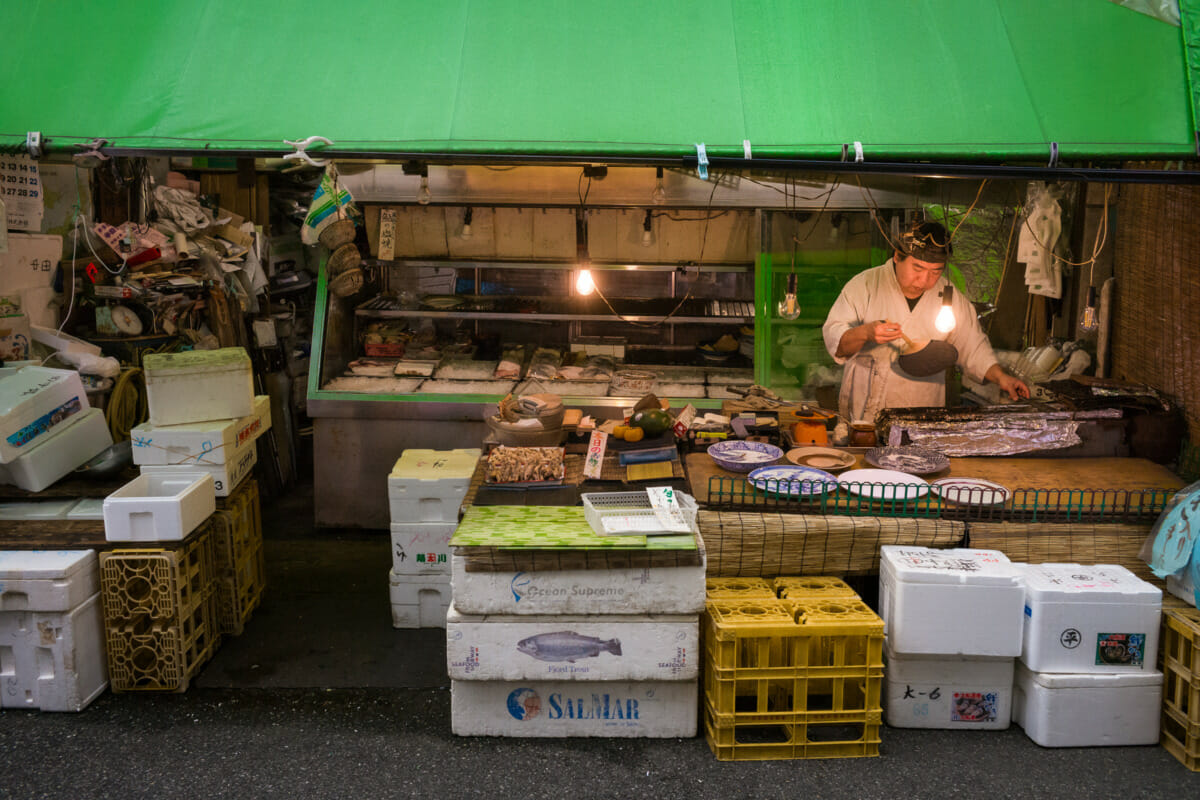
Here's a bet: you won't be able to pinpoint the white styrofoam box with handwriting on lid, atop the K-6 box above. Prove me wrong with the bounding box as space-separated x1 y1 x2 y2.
880 545 1025 656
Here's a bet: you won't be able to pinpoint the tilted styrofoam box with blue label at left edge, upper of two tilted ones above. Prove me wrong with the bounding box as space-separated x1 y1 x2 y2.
0 367 91 464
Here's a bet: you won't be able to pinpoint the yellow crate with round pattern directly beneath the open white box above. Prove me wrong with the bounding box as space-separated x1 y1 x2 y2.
100 522 214 627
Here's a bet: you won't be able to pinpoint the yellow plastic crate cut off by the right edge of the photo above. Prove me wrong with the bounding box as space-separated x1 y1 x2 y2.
1160 608 1200 771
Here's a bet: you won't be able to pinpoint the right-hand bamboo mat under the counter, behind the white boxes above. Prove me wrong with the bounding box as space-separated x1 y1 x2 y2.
967 522 1165 589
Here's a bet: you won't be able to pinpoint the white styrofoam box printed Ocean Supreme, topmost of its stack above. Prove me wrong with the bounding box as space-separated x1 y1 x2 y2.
450 555 704 614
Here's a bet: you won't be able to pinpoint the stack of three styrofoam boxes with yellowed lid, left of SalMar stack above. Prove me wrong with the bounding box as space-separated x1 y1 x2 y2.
388 449 481 627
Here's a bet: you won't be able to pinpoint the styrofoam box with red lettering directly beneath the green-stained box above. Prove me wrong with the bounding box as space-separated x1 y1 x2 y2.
130 395 271 465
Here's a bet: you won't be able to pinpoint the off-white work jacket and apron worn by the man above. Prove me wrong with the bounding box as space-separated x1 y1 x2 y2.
822 259 996 421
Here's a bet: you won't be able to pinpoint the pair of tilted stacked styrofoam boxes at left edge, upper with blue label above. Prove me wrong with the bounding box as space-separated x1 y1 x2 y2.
0 367 113 492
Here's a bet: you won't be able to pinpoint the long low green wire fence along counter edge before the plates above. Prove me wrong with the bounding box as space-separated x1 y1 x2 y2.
707 476 1177 523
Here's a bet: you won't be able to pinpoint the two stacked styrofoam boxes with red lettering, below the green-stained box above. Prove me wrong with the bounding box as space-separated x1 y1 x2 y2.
131 395 271 498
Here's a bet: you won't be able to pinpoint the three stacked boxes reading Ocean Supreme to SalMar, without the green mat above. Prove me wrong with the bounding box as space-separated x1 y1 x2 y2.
446 509 704 738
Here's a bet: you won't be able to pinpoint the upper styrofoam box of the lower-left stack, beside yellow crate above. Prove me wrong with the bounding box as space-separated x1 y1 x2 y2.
0 551 100 612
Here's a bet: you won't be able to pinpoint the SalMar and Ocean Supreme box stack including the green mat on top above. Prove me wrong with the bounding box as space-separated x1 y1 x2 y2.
446 506 704 738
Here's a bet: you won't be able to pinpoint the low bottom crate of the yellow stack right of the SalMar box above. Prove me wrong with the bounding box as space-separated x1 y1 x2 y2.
704 709 882 762
